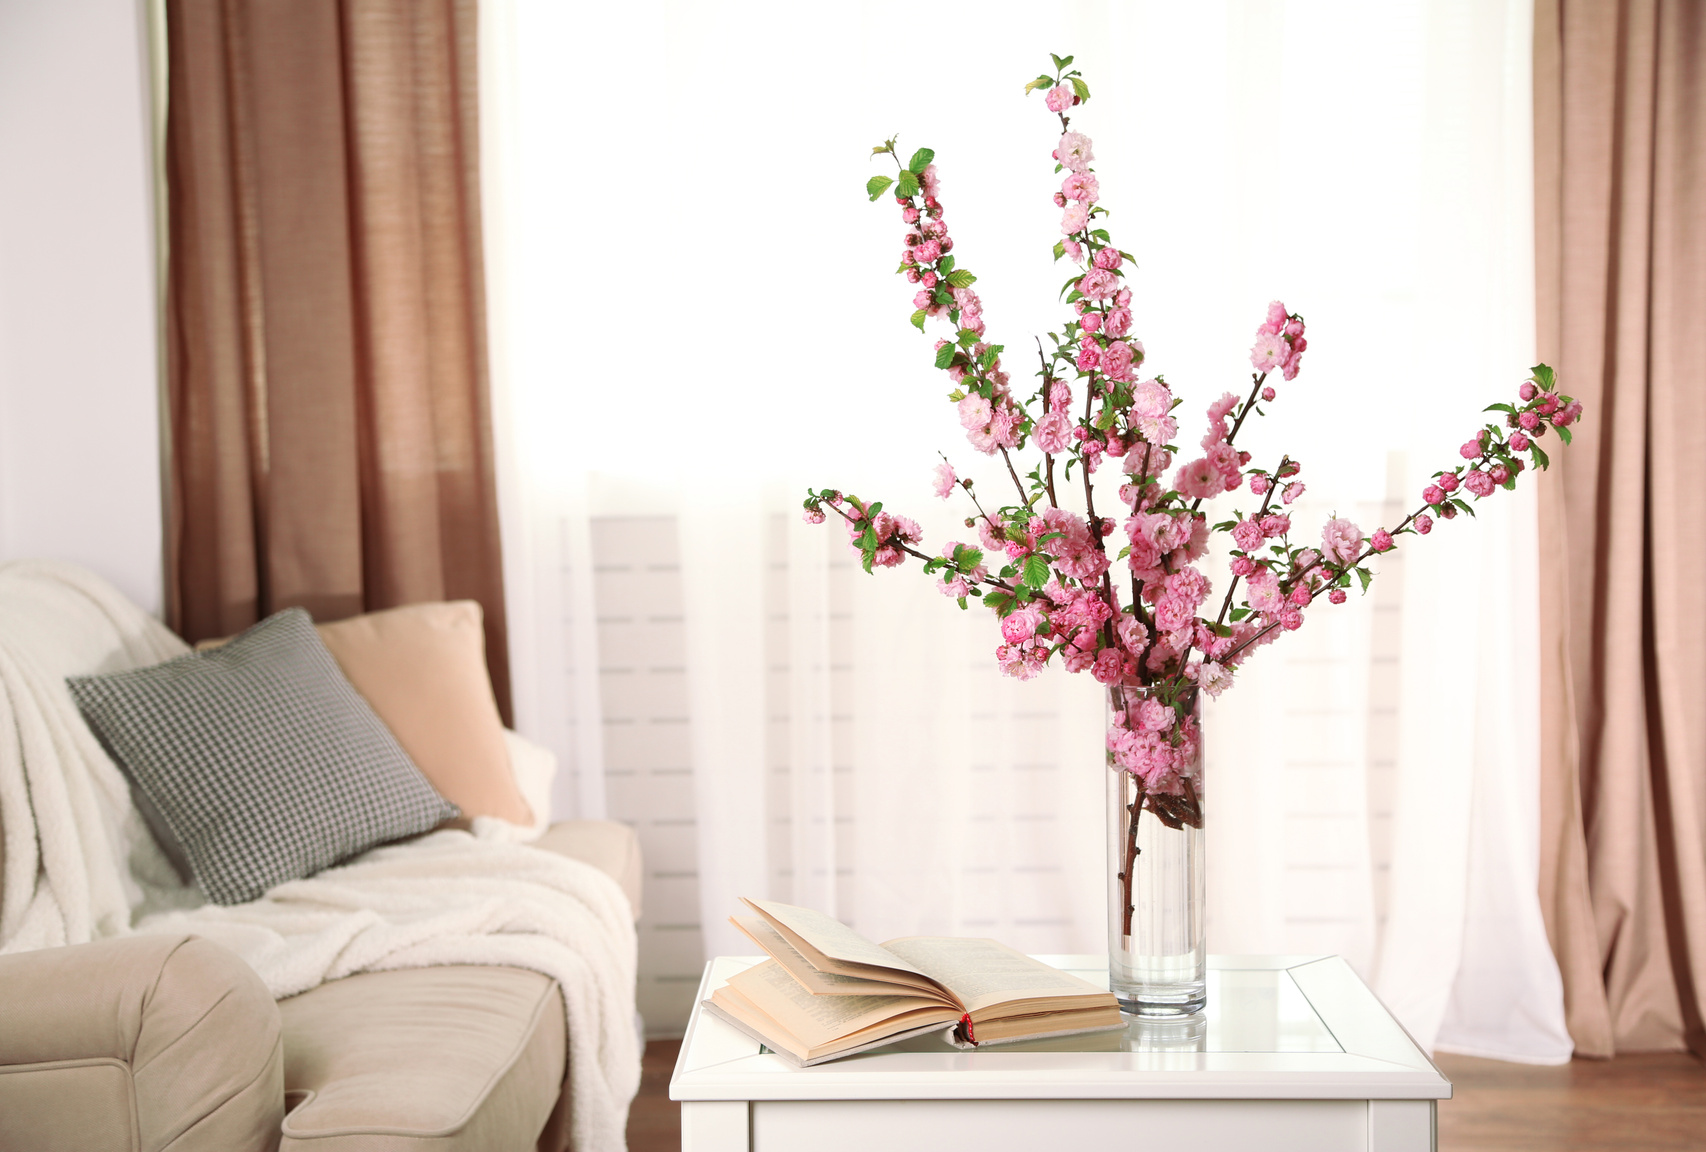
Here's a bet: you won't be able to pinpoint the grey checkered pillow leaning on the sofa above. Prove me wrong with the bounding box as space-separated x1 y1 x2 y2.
67 608 461 905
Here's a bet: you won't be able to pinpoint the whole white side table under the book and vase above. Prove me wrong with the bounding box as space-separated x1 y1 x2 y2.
669 956 1452 1152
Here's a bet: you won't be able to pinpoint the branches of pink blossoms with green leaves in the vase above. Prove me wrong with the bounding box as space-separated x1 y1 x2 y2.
805 56 1581 828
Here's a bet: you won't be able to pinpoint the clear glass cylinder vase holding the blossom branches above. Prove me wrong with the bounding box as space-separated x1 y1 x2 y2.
1107 684 1208 1017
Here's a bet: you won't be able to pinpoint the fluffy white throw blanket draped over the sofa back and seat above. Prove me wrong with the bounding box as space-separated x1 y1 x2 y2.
0 561 640 1152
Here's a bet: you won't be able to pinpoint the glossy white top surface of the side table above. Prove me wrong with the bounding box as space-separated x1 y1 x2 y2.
669 956 1452 1101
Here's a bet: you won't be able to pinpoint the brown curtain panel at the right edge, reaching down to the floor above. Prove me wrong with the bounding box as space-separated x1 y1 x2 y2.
1534 0 1706 1056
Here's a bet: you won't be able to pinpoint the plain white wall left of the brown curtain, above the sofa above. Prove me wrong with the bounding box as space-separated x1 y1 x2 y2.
0 0 162 613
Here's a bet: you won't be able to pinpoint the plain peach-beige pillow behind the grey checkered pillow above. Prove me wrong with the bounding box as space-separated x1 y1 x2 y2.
196 601 534 828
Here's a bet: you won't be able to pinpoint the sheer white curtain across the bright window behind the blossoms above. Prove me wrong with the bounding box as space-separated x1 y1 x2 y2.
483 0 1570 1060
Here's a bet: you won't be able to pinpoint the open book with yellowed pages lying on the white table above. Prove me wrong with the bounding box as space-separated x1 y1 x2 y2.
705 899 1124 1067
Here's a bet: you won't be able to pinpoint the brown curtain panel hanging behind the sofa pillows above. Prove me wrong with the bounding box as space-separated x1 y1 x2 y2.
165 0 510 720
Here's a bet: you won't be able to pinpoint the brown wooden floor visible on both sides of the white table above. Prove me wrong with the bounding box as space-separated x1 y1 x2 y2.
628 1039 1706 1152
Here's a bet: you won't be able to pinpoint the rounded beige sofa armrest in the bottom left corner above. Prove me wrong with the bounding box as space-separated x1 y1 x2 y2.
0 935 285 1152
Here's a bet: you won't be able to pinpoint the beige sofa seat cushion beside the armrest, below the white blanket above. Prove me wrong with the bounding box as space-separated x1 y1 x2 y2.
278 966 566 1152
